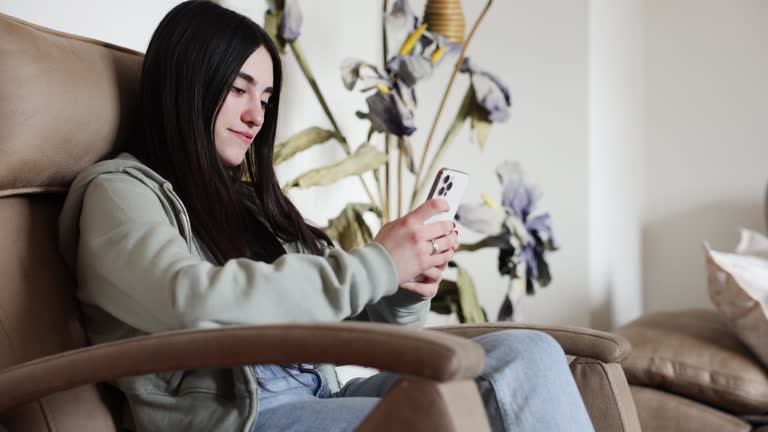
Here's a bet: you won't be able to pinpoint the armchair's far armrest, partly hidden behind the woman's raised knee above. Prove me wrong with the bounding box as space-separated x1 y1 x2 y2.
430 322 632 363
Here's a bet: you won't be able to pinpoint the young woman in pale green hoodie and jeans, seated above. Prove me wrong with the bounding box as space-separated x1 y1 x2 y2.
60 1 592 432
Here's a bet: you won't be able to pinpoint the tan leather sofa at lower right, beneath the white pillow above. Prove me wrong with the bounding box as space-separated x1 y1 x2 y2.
615 188 768 432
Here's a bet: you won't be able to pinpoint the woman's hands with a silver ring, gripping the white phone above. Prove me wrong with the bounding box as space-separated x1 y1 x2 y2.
373 199 459 290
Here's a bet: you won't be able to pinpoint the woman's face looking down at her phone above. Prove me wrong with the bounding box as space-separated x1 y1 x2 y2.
213 46 273 167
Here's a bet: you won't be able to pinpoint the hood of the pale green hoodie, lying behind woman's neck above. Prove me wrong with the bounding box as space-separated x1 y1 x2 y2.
59 153 186 270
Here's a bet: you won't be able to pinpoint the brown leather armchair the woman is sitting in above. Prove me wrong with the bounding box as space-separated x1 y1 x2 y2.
0 14 639 432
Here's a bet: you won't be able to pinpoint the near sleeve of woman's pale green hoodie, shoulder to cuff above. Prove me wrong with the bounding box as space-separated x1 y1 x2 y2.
77 174 397 332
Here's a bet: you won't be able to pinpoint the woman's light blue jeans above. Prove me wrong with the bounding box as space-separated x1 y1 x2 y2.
254 330 594 432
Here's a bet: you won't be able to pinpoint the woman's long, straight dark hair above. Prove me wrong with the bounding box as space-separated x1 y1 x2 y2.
134 0 331 264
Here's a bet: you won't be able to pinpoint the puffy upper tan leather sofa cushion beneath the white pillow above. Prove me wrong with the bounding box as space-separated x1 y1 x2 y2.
616 310 768 414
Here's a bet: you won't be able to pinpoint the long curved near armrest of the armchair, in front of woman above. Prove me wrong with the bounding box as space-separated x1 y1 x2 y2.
0 322 485 413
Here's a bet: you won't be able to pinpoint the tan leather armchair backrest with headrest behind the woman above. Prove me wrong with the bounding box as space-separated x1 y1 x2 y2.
0 14 142 432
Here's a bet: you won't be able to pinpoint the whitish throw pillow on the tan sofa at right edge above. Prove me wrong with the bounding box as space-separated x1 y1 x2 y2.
707 229 768 367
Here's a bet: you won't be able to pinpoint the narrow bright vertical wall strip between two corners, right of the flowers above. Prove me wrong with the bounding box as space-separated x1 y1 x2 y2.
589 0 645 329
